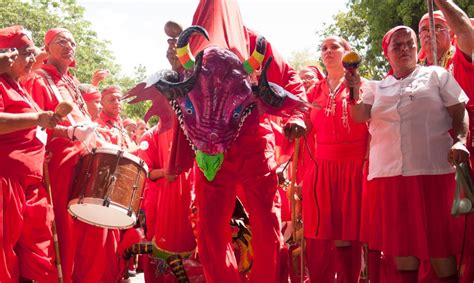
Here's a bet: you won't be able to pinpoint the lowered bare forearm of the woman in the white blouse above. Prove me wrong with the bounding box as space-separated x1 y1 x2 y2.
447 103 469 163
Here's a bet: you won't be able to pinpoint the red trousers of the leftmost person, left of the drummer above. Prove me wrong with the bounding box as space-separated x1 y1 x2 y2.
0 177 57 283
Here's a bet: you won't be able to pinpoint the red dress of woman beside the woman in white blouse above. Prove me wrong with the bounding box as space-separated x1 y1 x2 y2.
303 80 368 241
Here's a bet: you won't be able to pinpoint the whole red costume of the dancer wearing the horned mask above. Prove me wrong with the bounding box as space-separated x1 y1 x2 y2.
190 1 304 282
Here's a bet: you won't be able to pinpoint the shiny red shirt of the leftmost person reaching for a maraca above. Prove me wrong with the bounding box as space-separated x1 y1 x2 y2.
0 74 44 178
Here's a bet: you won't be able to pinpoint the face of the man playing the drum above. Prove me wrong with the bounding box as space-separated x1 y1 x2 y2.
46 32 76 67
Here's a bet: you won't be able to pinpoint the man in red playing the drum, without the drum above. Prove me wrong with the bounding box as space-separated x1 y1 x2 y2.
26 28 107 282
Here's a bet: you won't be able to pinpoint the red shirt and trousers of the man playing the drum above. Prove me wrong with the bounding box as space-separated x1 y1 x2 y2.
26 59 107 282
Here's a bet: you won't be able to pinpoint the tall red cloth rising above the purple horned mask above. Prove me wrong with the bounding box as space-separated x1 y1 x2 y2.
189 0 249 59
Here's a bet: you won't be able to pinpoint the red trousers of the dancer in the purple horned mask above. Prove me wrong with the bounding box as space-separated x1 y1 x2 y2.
195 149 282 283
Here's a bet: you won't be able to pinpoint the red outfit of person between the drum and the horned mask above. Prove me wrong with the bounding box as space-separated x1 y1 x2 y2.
138 126 196 282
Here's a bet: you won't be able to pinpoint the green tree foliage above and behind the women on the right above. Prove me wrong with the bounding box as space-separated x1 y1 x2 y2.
319 0 474 79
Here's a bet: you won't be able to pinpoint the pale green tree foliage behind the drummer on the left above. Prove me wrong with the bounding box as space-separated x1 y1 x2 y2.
0 0 148 122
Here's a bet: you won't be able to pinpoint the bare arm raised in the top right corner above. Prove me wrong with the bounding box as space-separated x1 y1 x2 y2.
435 0 474 60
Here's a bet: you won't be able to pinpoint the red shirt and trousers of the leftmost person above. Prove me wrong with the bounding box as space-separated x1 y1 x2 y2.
0 74 57 282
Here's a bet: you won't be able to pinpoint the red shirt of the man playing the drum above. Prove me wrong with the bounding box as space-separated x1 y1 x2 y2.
25 64 91 165
